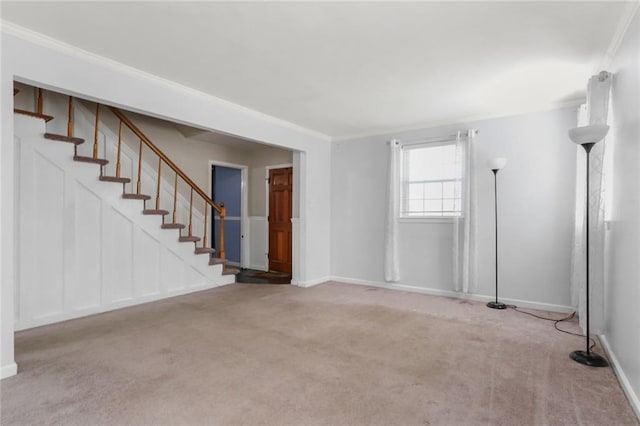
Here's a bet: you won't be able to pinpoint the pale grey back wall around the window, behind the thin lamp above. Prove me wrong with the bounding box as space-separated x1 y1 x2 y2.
331 108 576 310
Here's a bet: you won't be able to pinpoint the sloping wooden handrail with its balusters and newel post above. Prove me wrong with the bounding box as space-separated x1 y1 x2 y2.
109 106 227 259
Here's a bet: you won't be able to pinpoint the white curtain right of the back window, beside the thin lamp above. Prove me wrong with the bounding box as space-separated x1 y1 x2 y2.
453 129 478 293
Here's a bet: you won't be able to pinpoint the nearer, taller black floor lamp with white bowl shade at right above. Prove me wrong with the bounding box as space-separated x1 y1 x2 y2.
569 124 609 367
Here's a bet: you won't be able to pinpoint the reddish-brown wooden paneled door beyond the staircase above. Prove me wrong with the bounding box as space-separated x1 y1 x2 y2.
269 167 293 273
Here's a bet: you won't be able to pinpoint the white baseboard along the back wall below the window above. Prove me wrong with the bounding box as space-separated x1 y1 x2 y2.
331 276 574 313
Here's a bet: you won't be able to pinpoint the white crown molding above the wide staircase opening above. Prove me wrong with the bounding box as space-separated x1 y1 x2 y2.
0 19 331 142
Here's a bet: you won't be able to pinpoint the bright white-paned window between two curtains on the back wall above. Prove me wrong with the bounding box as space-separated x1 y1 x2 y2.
400 141 462 218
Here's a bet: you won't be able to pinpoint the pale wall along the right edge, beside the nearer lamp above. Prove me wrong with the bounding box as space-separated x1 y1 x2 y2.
605 9 640 416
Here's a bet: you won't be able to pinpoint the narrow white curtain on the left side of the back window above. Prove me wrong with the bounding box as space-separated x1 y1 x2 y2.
384 139 402 282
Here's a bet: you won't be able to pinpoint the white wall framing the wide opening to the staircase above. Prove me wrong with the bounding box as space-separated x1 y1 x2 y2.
0 23 331 375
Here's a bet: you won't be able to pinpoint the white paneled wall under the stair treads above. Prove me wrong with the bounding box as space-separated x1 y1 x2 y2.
14 114 235 330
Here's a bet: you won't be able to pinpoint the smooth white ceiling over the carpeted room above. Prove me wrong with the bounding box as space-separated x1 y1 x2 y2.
1 1 633 138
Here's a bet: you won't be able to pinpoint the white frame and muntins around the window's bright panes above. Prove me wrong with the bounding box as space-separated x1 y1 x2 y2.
398 138 464 223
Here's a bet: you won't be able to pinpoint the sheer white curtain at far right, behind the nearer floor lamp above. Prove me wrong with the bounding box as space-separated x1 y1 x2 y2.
571 72 612 334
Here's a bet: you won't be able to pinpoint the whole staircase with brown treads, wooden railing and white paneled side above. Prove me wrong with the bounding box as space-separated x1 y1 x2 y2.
14 85 239 329
